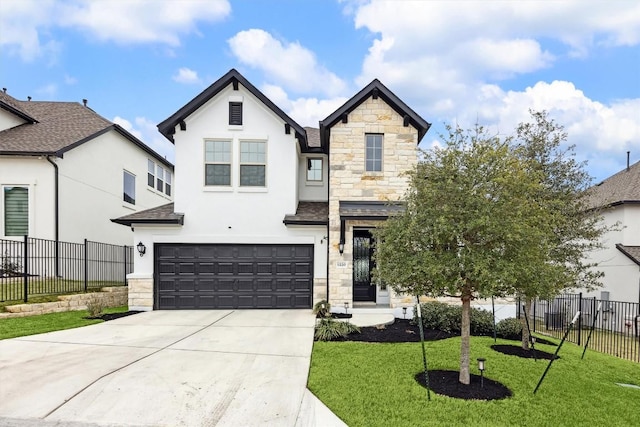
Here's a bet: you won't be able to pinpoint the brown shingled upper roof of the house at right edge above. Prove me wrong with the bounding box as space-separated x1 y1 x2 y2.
587 162 640 208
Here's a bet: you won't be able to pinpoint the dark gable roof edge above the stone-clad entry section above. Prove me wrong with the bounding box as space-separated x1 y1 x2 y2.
320 79 431 152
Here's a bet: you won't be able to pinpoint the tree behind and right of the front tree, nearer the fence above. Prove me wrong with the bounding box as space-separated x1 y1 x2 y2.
512 111 609 349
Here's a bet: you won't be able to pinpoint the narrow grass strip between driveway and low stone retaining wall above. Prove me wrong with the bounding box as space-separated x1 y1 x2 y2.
0 306 128 339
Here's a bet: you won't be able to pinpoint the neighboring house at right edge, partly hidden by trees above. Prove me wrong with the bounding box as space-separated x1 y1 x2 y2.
585 162 640 303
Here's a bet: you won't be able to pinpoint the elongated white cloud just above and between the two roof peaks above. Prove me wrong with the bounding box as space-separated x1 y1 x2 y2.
228 29 346 96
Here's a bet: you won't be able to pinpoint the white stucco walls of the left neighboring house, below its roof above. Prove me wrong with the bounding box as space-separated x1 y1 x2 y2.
0 130 171 245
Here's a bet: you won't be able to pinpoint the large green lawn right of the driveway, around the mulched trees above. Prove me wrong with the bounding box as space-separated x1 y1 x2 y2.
308 337 640 427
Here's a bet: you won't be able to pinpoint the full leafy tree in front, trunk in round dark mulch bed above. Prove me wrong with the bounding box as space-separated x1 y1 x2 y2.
376 128 549 384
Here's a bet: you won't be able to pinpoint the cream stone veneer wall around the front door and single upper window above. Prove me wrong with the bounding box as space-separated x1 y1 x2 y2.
329 97 418 307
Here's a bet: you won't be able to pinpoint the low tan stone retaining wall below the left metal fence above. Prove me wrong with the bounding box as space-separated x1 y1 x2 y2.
0 286 129 319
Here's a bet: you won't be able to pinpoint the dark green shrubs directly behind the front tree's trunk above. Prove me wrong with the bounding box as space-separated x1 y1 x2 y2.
413 301 500 335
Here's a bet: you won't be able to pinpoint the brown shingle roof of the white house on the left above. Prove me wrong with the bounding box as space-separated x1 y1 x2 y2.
0 92 173 169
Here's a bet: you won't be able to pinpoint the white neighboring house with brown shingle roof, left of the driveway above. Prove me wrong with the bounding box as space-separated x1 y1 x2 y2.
0 91 173 245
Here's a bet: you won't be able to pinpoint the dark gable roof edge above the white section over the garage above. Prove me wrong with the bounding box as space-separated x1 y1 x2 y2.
158 69 309 152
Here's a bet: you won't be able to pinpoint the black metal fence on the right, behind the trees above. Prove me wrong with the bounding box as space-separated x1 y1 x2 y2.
518 293 640 362
